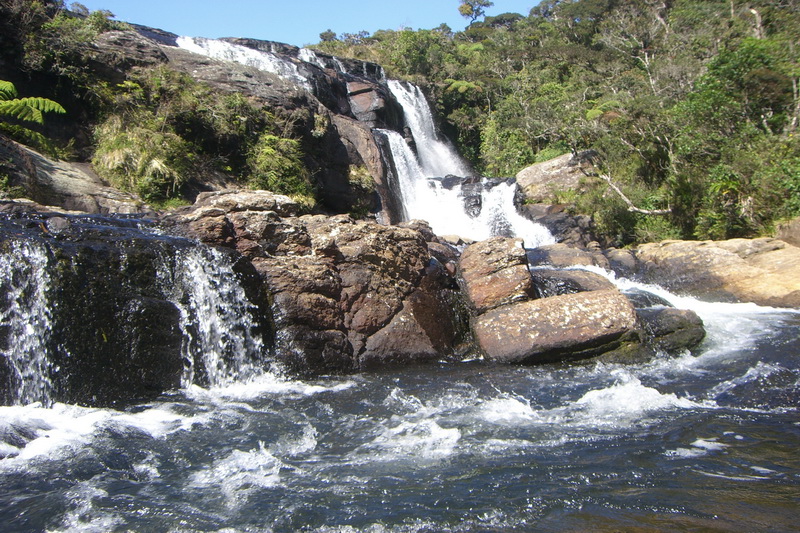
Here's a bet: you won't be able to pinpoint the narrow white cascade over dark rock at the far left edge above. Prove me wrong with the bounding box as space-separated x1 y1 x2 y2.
0 241 54 405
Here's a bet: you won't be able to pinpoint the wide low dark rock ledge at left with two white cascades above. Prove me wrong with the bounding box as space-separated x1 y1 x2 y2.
0 218 264 405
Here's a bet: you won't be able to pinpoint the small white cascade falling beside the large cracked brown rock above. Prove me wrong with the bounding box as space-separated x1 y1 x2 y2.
173 247 263 387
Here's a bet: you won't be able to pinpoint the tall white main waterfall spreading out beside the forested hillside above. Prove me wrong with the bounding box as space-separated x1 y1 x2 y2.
382 80 555 248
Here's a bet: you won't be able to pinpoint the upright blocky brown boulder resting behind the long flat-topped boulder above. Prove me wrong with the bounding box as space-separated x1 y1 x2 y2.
458 237 535 314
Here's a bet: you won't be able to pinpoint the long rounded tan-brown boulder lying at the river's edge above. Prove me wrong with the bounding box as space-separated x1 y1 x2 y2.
473 290 637 364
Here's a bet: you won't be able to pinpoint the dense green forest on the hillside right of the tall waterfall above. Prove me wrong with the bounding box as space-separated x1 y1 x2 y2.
316 0 800 245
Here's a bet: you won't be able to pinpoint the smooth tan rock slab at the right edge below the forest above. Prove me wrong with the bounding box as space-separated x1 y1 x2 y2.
636 238 800 307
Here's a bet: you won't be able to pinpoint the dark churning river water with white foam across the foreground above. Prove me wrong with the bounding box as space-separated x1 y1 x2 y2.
0 274 800 532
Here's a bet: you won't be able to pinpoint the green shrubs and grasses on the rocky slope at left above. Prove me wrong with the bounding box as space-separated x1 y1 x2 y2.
0 0 318 209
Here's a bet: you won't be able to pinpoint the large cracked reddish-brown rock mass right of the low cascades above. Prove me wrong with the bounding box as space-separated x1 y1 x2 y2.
167 191 467 372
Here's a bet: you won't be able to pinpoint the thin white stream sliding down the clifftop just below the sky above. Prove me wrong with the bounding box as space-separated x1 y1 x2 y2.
177 37 312 92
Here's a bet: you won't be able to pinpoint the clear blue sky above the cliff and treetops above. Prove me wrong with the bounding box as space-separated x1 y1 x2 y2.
73 0 539 46
